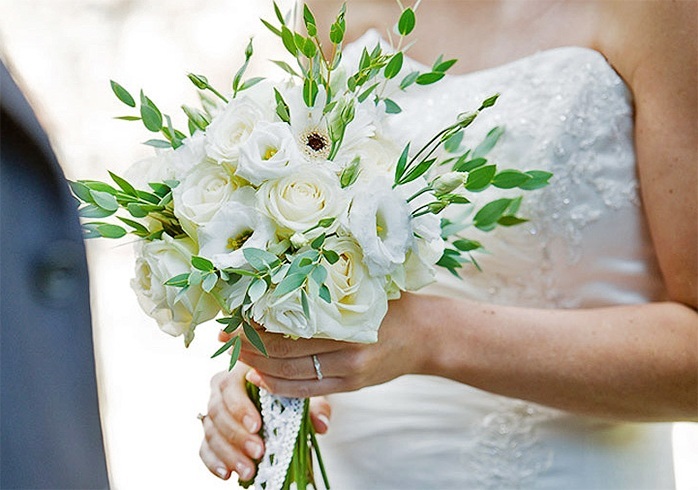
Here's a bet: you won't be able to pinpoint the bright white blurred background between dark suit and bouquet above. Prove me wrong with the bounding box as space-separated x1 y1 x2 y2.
0 0 698 490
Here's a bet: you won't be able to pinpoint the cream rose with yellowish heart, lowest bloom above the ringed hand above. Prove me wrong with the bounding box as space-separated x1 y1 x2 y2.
308 236 388 343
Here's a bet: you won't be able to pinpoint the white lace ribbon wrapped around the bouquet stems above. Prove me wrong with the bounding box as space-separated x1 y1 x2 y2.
254 389 303 490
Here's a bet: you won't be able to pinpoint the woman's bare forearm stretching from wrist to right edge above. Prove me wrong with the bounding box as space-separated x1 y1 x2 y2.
418 297 698 421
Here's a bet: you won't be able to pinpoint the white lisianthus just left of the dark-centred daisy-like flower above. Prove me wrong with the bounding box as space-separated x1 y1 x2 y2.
235 122 302 185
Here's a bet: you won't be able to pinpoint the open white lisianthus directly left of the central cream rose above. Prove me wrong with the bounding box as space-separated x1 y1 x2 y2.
198 197 275 269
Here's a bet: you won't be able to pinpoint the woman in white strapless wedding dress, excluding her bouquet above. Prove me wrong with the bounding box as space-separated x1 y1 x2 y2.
200 0 698 490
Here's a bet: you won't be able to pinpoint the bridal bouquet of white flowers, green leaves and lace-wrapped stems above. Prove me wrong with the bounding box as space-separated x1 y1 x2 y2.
71 1 550 490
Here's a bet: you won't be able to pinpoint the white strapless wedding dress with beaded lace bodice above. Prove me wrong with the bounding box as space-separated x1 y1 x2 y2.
321 31 674 490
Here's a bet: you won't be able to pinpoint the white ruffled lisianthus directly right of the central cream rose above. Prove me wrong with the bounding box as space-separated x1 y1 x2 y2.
348 178 413 276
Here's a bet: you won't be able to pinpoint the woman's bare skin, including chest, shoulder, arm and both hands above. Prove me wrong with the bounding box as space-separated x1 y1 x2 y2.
200 0 698 478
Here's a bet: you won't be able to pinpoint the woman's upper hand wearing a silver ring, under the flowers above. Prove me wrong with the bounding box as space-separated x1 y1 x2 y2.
240 293 428 398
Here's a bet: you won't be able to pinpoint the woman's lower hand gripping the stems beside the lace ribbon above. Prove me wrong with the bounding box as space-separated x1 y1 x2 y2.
199 362 330 481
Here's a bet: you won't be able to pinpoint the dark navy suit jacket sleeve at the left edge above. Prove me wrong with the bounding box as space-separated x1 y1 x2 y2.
0 64 108 489
